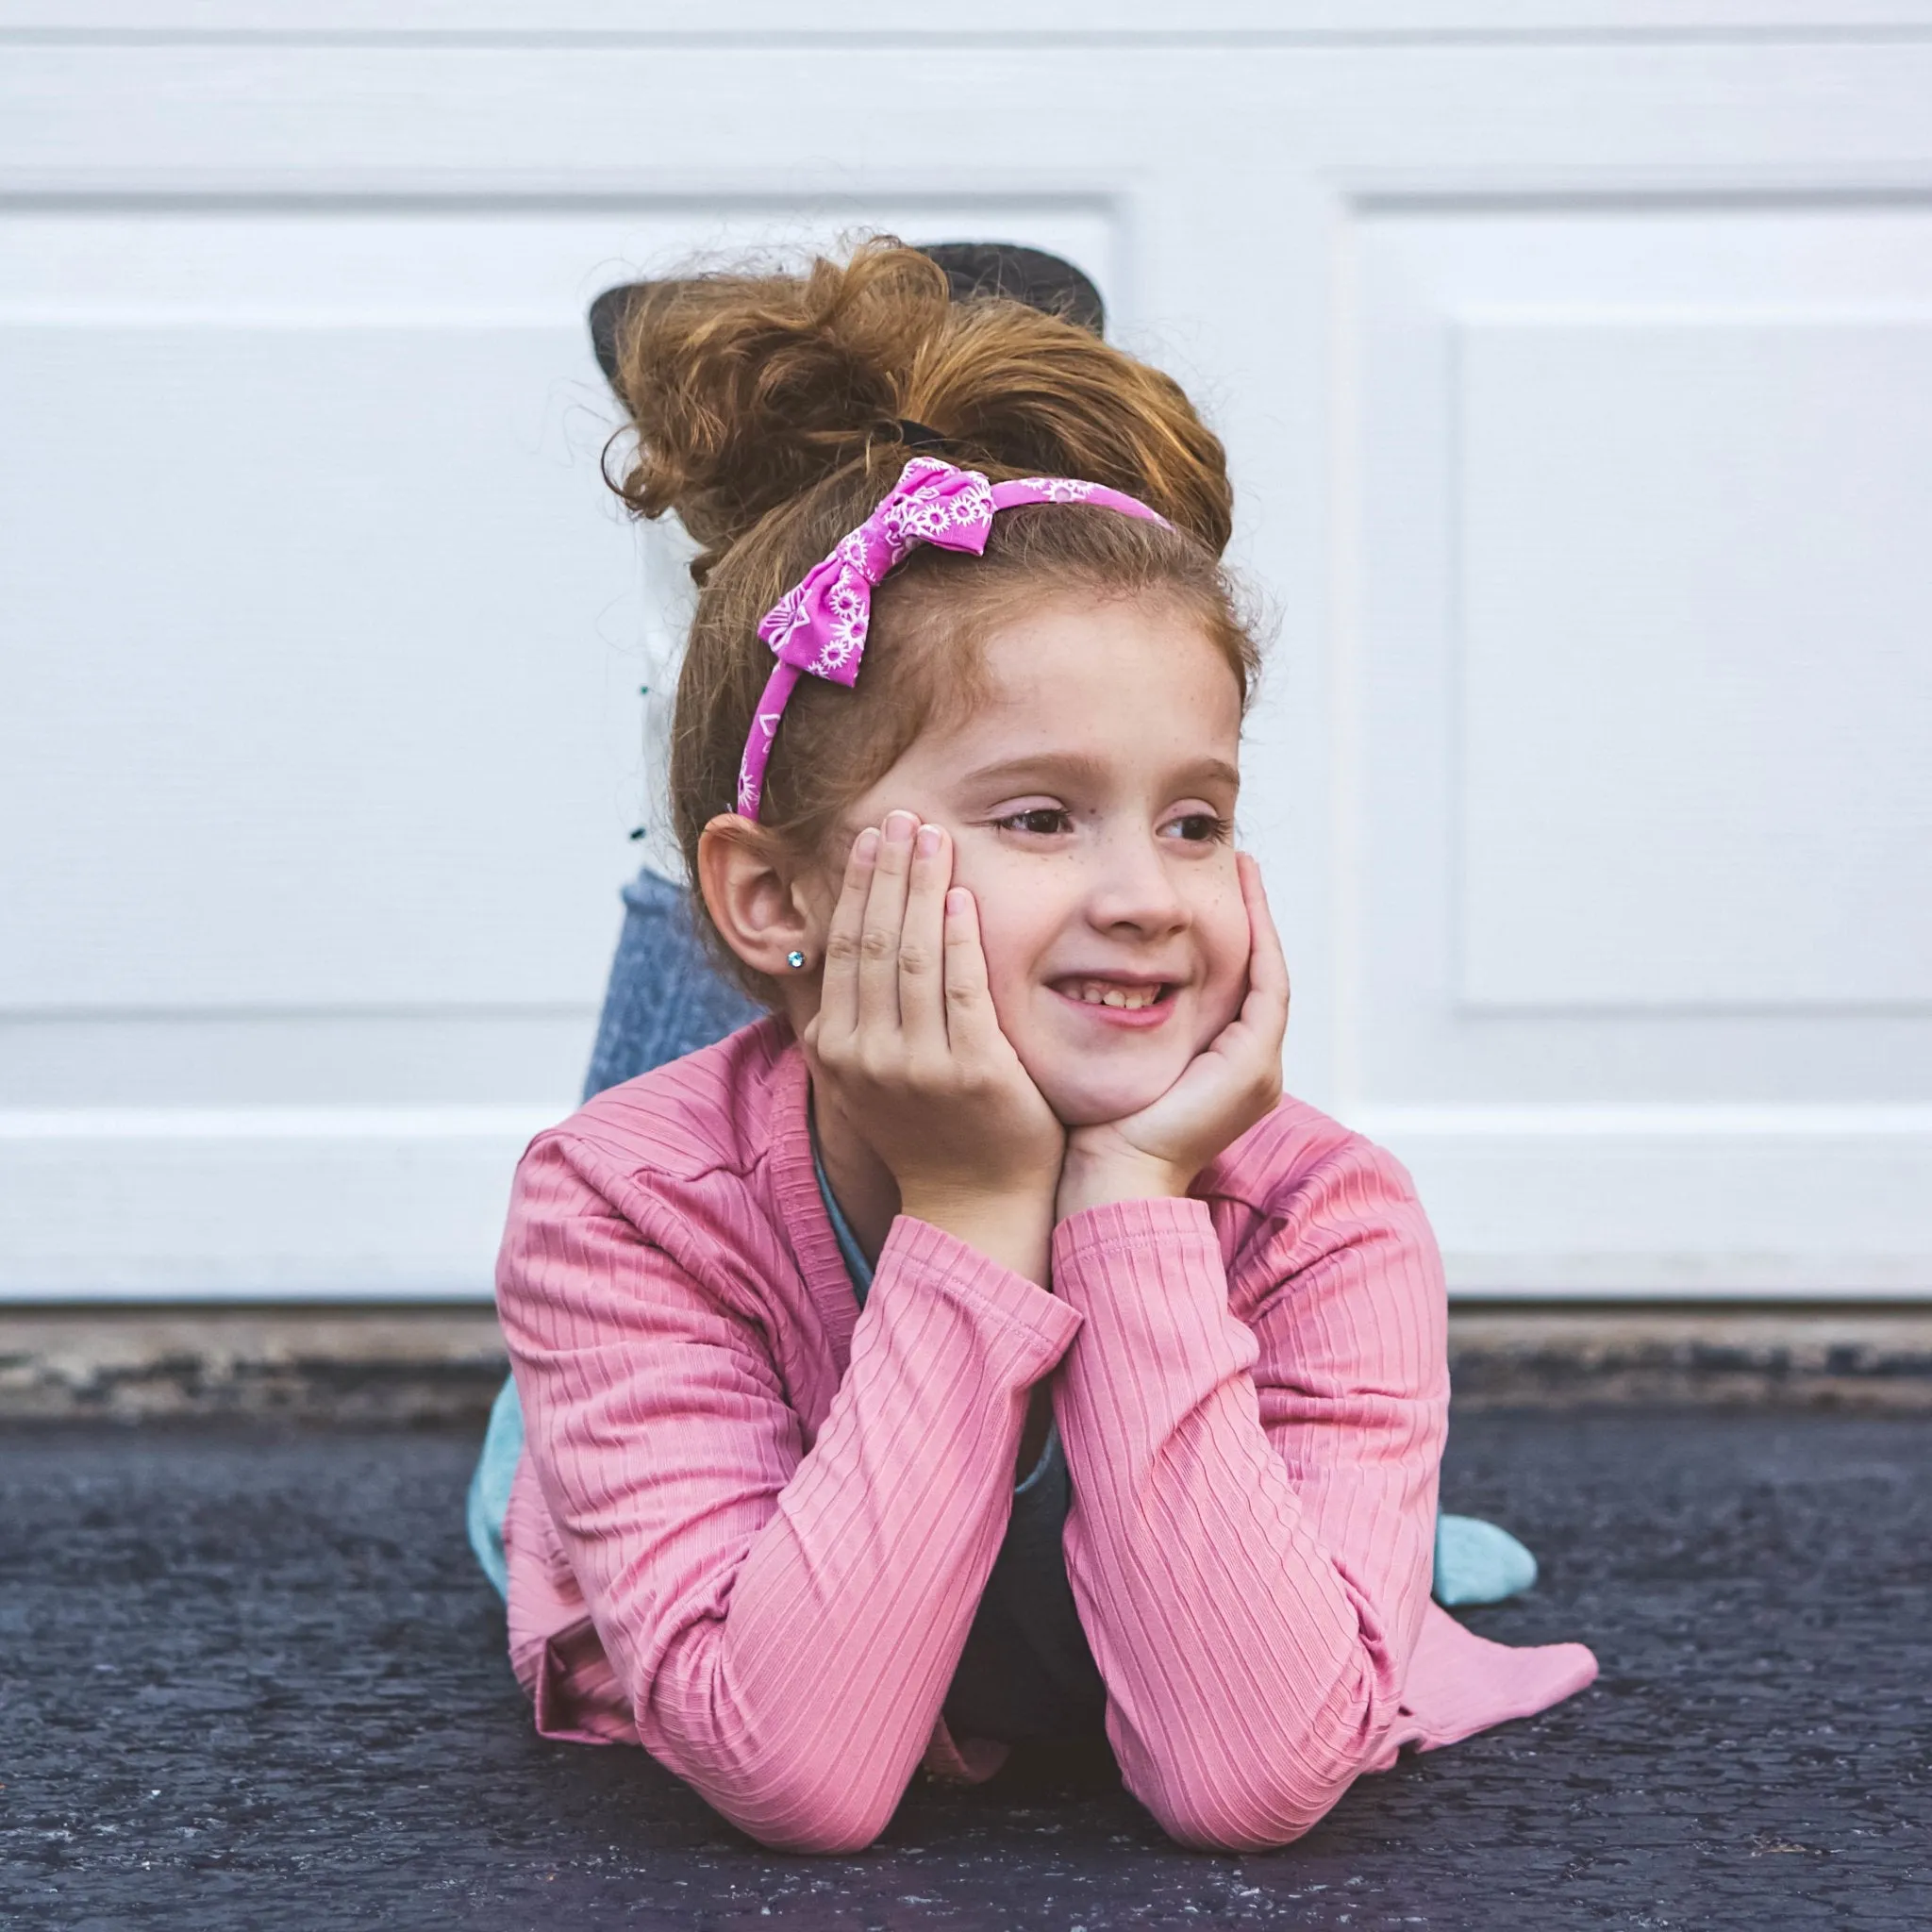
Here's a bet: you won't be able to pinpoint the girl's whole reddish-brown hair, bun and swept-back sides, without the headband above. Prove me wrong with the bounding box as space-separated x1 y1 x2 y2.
614 238 1257 1003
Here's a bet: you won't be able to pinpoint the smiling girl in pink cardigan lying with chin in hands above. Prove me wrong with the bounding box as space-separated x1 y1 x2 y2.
498 245 1596 1851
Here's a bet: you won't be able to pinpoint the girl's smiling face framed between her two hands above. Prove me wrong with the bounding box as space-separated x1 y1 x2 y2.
839 597 1248 1126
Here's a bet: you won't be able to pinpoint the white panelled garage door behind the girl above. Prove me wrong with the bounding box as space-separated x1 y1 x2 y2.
0 0 1932 1296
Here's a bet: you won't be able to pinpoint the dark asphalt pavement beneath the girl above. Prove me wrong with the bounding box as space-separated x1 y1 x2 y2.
0 1412 1932 1932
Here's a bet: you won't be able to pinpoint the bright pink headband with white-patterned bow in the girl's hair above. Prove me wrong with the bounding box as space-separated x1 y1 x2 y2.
738 456 1167 819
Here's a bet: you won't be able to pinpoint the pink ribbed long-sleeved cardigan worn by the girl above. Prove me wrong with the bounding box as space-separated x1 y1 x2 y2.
496 1020 1596 1851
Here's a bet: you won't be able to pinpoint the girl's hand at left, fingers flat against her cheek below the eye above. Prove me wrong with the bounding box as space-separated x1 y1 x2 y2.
804 811 1066 1285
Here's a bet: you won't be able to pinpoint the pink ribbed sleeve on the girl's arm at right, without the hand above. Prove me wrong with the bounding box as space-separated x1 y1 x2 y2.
1053 1141 1449 1849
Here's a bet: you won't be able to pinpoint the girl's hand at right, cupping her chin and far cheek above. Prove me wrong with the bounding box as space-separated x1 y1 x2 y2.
1055 852 1289 1221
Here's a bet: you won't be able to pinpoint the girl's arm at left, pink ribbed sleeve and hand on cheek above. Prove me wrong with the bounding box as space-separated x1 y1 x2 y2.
498 811 1080 1851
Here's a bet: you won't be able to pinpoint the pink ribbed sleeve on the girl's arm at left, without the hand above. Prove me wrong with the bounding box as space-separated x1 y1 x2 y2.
498 1140 1080 1851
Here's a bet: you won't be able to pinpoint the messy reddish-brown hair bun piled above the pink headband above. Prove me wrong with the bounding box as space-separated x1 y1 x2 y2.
610 238 1233 583
